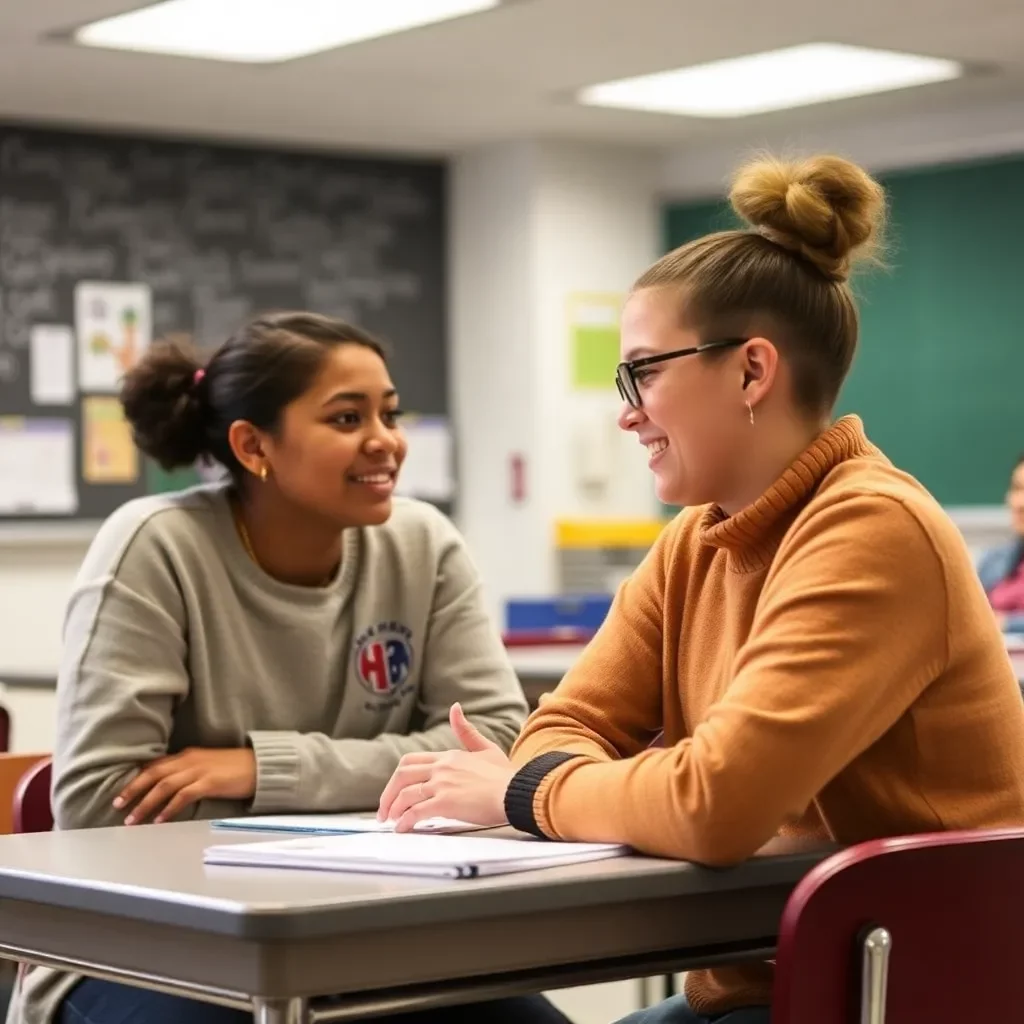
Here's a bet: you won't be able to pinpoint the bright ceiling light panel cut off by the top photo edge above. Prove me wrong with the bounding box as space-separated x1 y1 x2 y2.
75 0 501 63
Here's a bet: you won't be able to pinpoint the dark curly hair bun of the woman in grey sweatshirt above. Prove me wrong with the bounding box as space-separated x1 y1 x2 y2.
121 338 209 469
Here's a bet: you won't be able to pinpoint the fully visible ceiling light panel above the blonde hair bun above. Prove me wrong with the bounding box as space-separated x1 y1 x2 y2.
580 43 964 118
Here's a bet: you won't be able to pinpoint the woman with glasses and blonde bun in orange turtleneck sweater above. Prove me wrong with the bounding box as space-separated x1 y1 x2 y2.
379 157 1024 1024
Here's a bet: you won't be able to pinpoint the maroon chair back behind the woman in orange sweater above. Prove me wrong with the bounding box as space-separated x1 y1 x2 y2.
772 828 1024 1024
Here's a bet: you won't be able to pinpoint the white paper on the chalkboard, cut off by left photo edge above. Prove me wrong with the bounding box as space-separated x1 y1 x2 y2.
0 416 78 516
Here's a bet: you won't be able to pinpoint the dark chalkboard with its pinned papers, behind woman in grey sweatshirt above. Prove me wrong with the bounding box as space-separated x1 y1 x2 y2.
0 125 451 524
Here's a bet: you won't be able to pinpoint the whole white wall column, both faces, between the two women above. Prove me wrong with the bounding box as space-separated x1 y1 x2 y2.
451 142 658 617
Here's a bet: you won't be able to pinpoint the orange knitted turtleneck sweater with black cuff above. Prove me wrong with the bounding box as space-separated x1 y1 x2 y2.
506 417 1024 1013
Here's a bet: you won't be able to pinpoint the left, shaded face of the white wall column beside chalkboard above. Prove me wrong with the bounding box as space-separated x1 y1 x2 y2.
450 144 549 614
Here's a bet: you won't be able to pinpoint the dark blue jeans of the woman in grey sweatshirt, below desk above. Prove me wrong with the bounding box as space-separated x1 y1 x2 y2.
61 978 570 1024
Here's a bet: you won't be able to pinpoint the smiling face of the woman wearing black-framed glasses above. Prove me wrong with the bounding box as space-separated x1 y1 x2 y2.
618 288 751 505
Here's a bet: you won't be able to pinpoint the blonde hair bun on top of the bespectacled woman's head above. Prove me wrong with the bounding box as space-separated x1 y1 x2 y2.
729 156 886 281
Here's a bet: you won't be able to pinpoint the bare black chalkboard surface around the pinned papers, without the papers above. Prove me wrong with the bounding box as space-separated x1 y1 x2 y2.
0 126 447 521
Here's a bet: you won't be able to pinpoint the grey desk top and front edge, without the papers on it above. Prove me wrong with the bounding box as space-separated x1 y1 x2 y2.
0 822 829 1013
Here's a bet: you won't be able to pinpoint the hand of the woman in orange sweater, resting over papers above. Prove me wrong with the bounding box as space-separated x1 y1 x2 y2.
377 703 515 831
